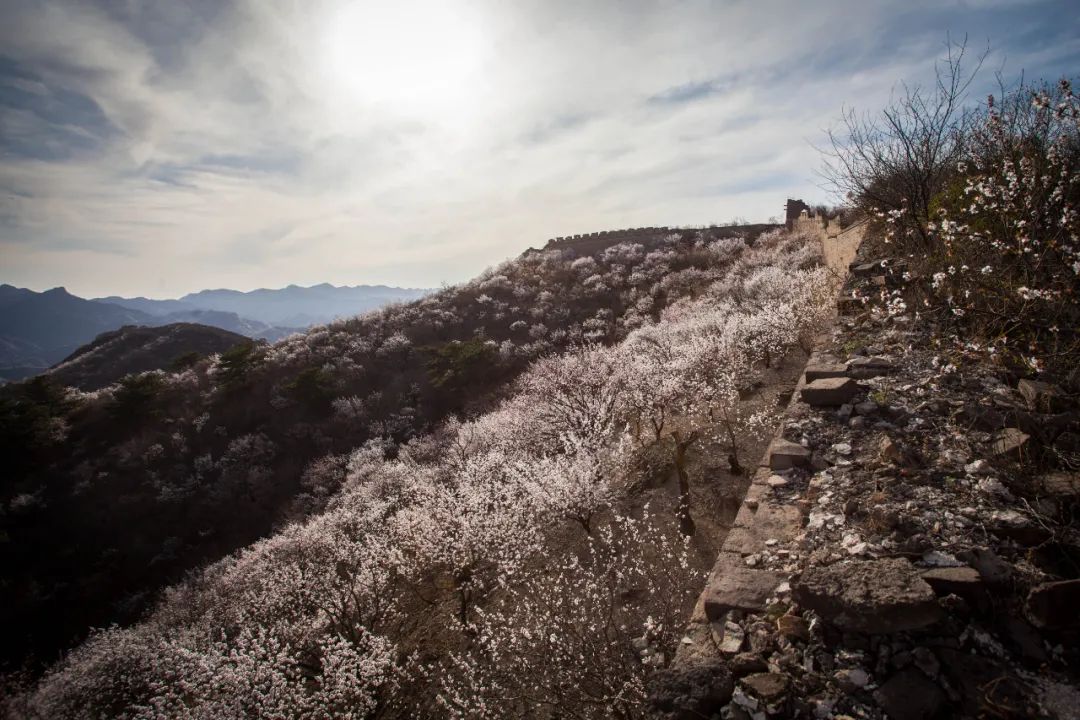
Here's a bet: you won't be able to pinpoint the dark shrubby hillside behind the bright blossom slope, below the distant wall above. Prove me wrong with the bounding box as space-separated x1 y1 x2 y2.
0 223 777 666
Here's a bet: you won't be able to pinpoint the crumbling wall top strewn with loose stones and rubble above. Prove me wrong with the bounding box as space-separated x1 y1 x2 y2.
652 250 1080 720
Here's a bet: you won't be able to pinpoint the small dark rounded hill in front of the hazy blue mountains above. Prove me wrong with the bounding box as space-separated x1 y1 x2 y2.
46 323 248 391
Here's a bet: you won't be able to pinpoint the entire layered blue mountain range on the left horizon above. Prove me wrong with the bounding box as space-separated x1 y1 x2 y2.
0 283 428 380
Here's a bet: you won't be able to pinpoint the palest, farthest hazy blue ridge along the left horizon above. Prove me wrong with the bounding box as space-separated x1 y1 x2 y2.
98 283 430 328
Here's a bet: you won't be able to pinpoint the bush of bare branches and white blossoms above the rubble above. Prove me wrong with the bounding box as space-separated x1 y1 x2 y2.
825 45 1080 385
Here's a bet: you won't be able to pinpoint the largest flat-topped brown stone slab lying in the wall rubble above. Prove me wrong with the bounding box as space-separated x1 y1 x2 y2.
792 558 942 634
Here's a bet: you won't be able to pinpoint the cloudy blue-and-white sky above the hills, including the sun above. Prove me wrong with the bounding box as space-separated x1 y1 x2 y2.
0 0 1080 298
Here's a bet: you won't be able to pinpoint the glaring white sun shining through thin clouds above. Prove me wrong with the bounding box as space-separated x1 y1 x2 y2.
323 0 484 112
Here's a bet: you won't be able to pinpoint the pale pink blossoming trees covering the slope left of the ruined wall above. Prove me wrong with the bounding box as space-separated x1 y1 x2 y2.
8 227 833 718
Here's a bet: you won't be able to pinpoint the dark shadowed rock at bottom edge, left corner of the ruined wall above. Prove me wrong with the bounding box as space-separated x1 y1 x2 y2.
648 661 734 720
